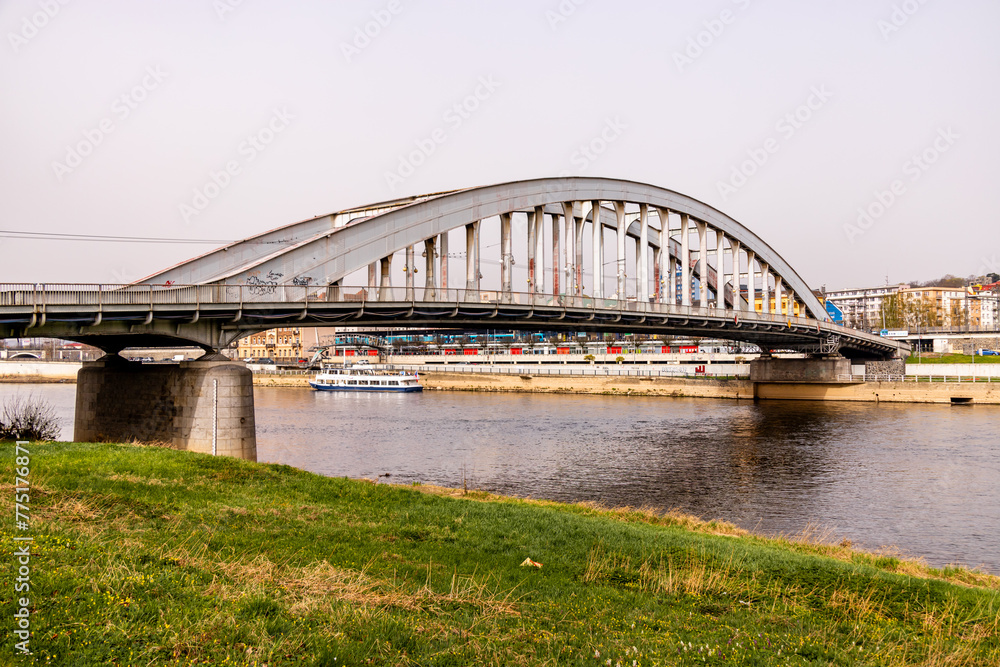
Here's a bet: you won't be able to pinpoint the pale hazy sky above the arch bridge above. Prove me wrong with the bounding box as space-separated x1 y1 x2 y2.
0 0 1000 290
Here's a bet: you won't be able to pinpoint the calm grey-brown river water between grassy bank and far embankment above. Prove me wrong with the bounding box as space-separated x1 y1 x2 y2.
9 385 1000 574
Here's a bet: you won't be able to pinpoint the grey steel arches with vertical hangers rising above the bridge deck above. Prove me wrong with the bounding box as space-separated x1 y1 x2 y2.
140 177 827 320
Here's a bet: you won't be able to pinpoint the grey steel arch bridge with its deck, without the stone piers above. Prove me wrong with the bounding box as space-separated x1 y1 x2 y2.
0 177 907 358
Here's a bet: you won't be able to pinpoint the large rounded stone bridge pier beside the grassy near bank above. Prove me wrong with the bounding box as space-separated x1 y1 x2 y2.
73 354 257 461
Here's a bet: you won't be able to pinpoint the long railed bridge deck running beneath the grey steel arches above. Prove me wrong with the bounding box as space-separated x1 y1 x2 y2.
0 284 908 358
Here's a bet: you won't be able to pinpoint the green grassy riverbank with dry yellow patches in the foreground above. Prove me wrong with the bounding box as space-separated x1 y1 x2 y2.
0 443 1000 667
